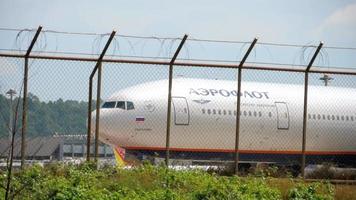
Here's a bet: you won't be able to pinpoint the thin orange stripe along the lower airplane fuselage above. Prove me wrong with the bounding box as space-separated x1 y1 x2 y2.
123 146 356 155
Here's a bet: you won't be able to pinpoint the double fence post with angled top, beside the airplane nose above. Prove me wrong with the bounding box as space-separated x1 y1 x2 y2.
87 30 116 161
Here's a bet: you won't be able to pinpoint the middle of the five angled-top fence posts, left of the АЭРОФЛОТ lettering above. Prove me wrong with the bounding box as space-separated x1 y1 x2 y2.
166 35 188 167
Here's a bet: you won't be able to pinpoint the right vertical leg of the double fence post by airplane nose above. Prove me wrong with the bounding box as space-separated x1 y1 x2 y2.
95 62 102 162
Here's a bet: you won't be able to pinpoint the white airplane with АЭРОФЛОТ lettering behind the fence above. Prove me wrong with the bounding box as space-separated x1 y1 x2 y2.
92 78 356 166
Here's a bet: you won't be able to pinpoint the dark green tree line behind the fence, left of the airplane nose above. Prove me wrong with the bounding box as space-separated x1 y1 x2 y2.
0 93 95 137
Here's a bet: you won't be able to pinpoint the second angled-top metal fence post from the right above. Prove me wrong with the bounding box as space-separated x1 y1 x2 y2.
235 38 258 174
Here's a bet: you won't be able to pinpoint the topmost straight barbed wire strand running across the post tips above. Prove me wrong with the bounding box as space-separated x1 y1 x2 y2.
0 27 356 50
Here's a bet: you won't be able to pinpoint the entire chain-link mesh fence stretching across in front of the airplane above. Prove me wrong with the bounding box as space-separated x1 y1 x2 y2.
0 27 356 178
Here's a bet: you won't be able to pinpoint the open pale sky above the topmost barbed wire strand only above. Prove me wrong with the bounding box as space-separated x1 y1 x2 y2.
0 0 356 46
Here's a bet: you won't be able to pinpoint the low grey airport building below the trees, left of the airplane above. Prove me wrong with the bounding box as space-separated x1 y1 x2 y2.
0 134 114 164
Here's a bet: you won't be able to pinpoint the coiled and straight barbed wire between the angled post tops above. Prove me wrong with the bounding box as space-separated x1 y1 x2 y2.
0 27 356 71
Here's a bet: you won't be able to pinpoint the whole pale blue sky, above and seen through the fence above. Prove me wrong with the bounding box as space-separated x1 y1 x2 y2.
0 0 356 100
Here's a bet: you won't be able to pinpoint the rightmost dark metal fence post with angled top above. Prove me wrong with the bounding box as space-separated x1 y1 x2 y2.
301 42 323 178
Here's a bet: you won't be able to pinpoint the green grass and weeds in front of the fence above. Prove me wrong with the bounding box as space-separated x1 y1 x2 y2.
0 163 356 200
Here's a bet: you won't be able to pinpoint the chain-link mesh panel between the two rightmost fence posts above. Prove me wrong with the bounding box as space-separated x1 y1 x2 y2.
240 69 304 173
